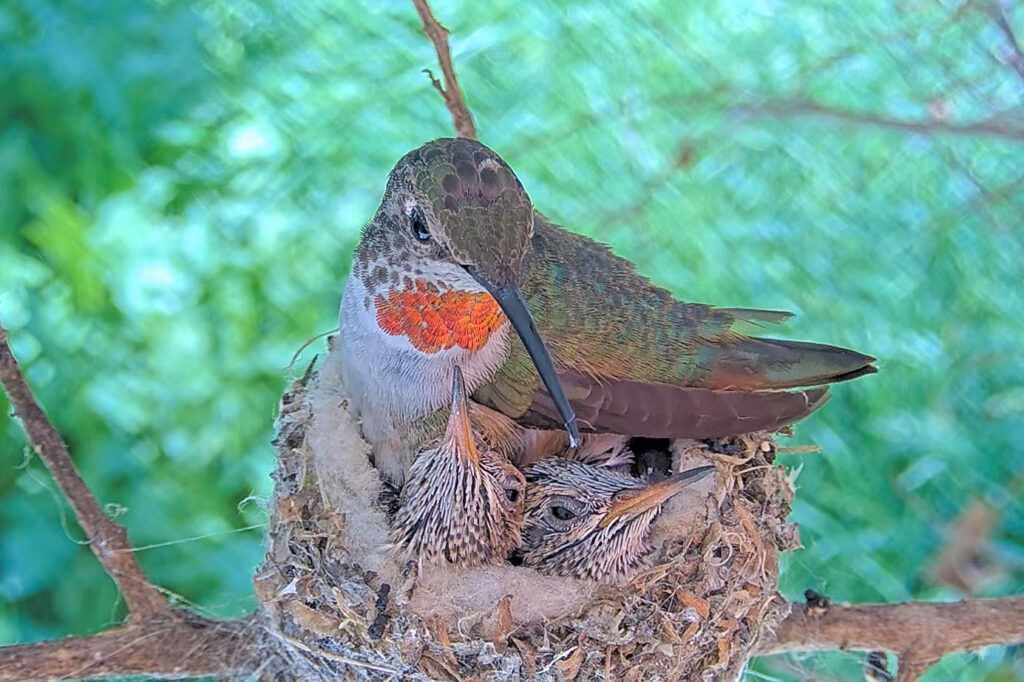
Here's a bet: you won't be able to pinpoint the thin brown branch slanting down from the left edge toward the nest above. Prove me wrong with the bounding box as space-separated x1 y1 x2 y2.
0 324 167 617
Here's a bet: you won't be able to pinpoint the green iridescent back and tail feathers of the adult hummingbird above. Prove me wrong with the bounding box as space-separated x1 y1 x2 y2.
476 213 873 425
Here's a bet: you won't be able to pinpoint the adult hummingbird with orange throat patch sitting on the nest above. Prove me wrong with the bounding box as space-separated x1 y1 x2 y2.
339 138 874 482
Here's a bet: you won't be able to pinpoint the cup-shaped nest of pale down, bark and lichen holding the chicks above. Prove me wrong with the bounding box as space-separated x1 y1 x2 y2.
255 352 799 681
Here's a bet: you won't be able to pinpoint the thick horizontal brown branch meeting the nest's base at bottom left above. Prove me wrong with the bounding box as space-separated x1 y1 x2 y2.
0 611 259 682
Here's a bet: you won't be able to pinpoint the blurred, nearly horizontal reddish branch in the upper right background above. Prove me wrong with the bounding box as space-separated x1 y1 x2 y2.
733 99 1024 142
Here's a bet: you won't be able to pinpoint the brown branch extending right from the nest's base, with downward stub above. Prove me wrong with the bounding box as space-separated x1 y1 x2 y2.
757 596 1024 682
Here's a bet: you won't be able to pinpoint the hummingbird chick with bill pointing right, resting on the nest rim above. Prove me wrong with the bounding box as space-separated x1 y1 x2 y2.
520 458 715 582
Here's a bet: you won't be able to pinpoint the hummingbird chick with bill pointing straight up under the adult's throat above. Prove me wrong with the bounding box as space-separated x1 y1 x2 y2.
391 367 526 567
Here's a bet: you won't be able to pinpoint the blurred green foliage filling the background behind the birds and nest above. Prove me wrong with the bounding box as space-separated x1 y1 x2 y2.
0 0 1024 680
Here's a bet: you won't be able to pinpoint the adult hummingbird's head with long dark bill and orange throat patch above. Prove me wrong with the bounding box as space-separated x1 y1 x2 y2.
364 138 580 441
